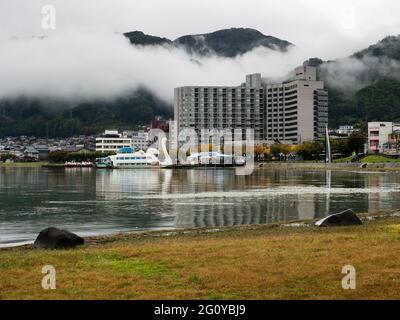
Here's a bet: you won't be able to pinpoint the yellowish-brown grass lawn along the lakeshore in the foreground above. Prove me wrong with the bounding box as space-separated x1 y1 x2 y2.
0 218 400 299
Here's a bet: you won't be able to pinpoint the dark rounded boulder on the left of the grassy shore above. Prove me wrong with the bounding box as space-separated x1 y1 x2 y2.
33 228 85 249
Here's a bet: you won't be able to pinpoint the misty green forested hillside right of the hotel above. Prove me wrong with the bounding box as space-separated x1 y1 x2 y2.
305 36 400 127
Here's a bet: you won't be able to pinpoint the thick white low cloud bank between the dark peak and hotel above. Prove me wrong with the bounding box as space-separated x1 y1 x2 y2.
0 33 307 102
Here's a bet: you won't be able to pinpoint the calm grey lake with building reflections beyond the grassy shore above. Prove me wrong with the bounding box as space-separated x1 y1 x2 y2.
0 167 400 246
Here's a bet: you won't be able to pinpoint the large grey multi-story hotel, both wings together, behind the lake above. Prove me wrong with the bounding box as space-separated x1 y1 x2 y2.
174 67 328 143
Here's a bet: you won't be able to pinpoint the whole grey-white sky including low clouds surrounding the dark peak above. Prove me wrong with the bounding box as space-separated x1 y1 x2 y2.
0 0 400 101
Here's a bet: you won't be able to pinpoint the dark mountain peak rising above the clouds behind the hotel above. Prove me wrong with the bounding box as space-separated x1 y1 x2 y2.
124 28 293 58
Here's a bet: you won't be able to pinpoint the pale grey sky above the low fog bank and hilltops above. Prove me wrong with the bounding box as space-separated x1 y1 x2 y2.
0 0 400 59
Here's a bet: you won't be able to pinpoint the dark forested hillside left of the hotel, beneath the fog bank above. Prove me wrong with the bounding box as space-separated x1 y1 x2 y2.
0 89 172 137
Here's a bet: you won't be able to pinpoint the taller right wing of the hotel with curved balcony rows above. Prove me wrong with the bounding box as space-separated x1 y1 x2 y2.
265 67 328 143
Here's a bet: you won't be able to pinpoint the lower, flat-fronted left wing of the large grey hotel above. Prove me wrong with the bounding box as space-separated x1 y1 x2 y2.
174 74 265 140
